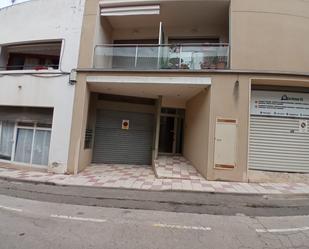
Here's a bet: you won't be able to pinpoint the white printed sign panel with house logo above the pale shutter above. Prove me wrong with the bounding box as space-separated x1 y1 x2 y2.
251 90 309 118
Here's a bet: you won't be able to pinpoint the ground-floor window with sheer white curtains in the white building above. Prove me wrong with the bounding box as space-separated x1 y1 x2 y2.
0 106 53 167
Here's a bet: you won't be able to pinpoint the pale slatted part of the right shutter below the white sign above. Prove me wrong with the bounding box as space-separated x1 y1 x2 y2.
249 116 309 172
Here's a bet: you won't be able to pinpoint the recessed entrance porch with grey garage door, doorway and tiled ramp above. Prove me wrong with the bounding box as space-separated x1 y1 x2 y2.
70 74 211 179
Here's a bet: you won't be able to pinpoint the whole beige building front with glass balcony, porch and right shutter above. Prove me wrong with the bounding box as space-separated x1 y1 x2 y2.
68 0 309 181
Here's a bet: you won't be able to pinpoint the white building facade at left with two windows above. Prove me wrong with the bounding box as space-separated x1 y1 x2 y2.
0 0 84 173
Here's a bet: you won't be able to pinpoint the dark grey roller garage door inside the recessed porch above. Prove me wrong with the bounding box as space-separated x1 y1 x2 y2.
93 109 154 165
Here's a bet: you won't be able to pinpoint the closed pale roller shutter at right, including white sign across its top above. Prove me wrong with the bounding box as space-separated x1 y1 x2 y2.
249 91 309 172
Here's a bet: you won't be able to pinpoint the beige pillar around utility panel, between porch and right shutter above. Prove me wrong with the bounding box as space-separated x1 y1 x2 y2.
207 74 250 181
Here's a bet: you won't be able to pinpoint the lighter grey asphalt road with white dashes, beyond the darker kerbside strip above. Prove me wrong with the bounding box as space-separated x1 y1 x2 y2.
0 195 309 249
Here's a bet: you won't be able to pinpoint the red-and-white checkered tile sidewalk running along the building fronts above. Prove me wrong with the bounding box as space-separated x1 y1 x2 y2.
0 164 309 194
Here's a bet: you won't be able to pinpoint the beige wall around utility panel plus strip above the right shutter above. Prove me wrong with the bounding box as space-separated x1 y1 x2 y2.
207 73 309 181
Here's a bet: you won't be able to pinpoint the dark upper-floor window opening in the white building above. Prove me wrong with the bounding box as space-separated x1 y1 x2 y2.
0 42 61 70
